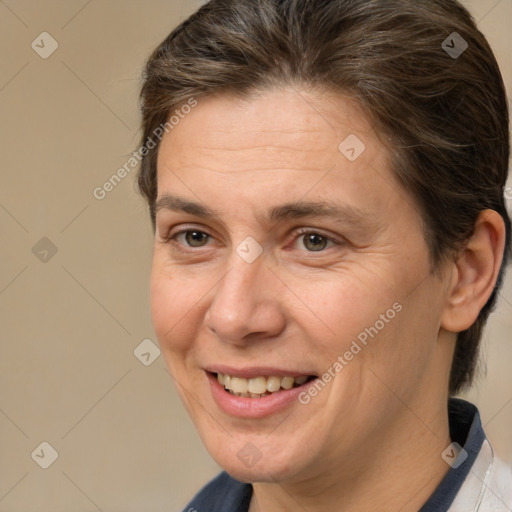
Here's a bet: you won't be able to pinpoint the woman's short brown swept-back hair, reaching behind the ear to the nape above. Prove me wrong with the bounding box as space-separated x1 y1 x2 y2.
138 0 510 394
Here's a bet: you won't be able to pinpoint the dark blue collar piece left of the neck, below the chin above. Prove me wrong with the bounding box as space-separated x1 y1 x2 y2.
183 471 252 512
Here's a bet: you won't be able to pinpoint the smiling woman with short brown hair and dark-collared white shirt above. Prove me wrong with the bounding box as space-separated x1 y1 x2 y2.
139 0 512 512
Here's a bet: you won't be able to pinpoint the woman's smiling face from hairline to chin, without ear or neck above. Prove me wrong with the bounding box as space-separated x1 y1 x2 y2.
151 88 449 488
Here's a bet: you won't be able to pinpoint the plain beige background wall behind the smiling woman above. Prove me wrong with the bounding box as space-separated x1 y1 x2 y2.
0 0 512 512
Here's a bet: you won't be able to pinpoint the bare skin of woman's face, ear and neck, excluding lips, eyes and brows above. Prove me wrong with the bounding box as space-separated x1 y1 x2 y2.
151 88 504 512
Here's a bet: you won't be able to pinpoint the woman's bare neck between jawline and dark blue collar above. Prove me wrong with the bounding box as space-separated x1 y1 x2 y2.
249 404 451 512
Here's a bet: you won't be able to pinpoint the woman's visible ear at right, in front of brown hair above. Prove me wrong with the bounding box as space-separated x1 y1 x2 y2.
441 210 505 332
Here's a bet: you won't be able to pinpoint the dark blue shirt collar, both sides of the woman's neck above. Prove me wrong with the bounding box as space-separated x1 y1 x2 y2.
183 398 485 512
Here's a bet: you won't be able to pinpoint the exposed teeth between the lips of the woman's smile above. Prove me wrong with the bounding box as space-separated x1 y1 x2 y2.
213 373 317 398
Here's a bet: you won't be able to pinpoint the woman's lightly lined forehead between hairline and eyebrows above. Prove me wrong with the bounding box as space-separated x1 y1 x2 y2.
153 88 404 222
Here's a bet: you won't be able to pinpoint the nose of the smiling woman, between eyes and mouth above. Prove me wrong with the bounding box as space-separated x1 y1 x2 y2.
204 251 286 346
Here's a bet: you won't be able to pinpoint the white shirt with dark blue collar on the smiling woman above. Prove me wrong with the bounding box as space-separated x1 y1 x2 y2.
183 398 512 512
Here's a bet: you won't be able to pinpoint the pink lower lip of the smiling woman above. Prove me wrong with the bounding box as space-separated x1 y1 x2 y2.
205 372 315 418
